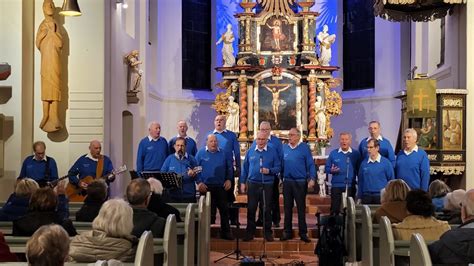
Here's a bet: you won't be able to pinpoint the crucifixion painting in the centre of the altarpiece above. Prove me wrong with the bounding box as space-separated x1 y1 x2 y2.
256 77 301 131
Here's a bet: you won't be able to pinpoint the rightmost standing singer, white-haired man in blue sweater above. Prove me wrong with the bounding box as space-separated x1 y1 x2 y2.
395 128 430 191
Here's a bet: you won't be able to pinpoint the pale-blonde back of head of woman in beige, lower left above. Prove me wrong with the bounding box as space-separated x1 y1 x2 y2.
92 199 133 237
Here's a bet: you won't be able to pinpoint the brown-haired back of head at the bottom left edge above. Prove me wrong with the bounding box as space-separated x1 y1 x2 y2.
26 224 69 266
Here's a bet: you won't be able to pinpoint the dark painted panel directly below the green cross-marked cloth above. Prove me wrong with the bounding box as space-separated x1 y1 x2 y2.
412 117 438 150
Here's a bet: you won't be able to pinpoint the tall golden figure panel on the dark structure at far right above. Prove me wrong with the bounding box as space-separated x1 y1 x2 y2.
442 109 463 150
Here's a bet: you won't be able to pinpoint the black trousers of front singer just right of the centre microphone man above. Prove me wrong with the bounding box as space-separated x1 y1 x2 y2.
283 181 308 237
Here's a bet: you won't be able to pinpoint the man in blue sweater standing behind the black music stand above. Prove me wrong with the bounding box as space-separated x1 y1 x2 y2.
161 138 197 203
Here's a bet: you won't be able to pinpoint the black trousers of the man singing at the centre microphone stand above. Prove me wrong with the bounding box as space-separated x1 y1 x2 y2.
247 183 273 237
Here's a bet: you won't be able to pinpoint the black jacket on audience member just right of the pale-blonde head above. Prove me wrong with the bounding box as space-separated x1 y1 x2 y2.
132 206 166 238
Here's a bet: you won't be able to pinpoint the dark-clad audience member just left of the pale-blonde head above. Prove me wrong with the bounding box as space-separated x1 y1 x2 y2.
76 180 107 222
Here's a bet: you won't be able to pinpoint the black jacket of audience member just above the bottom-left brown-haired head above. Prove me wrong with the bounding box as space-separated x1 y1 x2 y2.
12 211 77 236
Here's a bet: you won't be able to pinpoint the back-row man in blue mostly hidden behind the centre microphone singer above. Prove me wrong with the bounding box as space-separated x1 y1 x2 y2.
250 121 283 227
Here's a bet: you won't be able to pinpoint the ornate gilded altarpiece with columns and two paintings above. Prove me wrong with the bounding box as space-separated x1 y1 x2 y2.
213 0 342 154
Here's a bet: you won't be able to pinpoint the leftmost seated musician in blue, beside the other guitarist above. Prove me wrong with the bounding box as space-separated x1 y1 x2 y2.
18 141 58 187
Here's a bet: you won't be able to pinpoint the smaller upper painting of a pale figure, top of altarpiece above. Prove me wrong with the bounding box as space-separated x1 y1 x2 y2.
259 16 296 52
